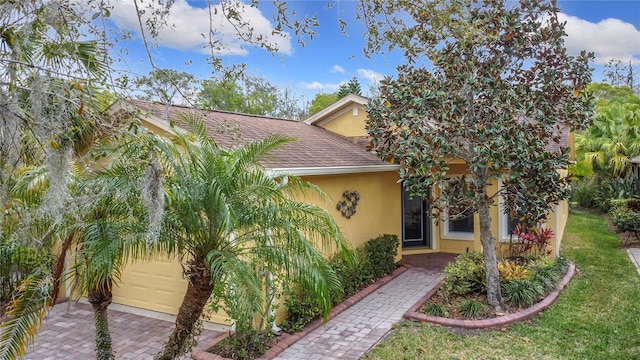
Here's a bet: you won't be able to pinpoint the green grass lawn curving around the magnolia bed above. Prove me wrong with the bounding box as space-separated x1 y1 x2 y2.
364 211 640 360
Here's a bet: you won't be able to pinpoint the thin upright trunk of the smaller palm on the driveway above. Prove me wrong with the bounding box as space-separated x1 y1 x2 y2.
88 289 115 360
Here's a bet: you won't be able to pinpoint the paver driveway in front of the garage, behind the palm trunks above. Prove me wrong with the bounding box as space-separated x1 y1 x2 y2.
19 302 220 360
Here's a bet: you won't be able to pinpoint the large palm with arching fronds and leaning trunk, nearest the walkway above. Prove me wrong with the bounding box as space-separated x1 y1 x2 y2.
157 118 348 359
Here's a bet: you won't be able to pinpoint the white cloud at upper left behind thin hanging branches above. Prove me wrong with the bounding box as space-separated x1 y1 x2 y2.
111 0 293 55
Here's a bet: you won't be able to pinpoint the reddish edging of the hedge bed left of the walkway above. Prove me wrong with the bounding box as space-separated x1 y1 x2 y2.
191 265 408 360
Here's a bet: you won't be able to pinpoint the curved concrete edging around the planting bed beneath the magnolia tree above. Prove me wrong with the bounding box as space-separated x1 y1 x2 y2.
404 262 576 329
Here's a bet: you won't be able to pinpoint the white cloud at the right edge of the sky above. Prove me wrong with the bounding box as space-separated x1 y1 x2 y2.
558 13 640 64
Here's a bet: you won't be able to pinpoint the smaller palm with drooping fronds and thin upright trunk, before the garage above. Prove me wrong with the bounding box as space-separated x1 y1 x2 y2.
70 144 154 360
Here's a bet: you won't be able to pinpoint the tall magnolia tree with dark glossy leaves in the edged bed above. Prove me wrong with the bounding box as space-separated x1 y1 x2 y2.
360 0 592 312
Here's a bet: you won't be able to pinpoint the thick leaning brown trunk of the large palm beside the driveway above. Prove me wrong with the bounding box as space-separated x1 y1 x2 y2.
156 260 213 360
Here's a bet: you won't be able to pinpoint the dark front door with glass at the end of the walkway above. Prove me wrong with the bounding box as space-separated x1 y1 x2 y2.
402 187 431 248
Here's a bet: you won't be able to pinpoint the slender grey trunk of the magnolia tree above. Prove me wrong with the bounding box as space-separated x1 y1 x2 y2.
478 202 504 313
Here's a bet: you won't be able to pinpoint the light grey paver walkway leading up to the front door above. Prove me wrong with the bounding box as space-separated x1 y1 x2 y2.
276 267 441 360
